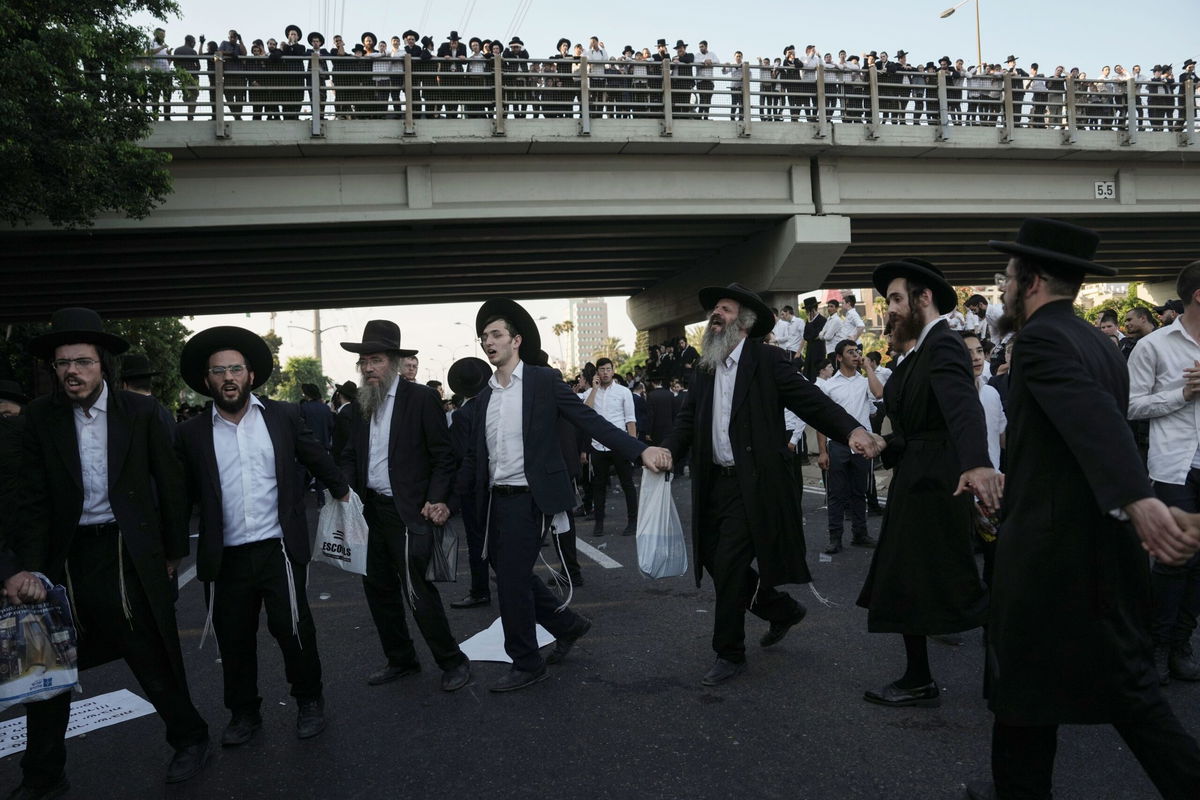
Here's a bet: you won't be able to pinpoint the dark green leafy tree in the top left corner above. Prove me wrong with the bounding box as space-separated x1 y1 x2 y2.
0 0 179 227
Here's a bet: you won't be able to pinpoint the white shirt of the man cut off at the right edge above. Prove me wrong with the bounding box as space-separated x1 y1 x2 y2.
1129 318 1200 486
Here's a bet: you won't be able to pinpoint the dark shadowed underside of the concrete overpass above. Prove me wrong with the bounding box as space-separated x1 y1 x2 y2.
0 213 1200 323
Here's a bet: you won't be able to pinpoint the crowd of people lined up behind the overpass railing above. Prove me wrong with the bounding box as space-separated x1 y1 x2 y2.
143 25 1200 131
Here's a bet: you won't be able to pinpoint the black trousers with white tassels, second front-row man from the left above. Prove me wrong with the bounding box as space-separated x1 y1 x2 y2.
204 539 322 714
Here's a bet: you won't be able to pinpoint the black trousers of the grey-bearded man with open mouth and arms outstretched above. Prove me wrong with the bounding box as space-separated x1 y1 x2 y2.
700 474 799 663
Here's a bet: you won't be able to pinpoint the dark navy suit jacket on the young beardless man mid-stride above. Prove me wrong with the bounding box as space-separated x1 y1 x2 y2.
457 363 646 519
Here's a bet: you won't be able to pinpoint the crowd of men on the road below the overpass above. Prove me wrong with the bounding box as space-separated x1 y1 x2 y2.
0 219 1200 800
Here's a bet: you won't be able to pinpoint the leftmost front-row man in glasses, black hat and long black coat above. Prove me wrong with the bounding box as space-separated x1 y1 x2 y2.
12 308 209 796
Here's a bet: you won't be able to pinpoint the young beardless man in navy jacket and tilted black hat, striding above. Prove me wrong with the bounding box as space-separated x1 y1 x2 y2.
457 297 671 692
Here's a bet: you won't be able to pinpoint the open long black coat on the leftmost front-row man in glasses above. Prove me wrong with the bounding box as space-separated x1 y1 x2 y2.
11 386 188 682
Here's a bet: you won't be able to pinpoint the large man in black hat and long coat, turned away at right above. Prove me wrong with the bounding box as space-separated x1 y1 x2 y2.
964 218 1200 800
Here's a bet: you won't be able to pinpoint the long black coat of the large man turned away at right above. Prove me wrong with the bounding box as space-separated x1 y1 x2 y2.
988 301 1157 724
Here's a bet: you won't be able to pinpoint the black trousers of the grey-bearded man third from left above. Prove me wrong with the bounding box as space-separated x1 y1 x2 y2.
362 492 467 669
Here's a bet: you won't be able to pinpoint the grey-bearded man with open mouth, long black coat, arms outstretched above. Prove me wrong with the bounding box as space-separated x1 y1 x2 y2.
665 283 882 686
